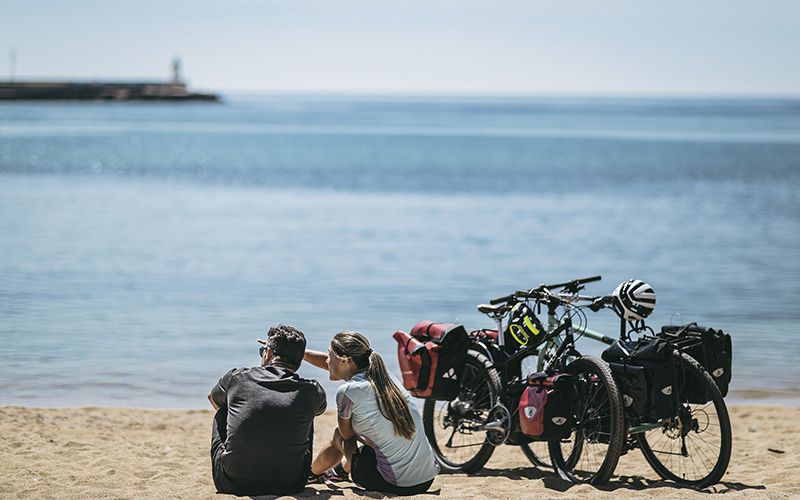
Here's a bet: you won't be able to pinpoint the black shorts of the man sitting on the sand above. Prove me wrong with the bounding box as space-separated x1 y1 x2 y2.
211 408 314 496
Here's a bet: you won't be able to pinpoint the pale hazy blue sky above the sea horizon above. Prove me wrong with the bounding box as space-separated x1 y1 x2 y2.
0 0 800 96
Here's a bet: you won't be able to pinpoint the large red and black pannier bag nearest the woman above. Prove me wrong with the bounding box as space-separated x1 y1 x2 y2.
393 320 469 401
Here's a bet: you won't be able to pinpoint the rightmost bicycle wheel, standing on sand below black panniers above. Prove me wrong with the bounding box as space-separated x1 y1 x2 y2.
637 352 732 488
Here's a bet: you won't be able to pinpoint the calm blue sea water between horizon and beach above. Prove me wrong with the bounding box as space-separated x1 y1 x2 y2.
0 96 800 407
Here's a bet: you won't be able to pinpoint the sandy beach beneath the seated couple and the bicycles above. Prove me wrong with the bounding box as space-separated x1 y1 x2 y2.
0 405 800 499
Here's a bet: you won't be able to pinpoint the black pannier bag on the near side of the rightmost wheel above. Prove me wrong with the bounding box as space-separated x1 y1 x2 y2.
602 337 683 421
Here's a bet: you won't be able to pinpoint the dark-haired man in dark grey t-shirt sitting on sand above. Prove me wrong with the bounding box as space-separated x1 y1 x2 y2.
208 325 326 496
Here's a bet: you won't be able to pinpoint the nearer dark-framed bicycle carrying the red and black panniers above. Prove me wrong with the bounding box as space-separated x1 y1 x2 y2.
423 277 625 485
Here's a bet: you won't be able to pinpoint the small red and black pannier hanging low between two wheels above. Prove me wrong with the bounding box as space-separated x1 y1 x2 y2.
519 372 576 440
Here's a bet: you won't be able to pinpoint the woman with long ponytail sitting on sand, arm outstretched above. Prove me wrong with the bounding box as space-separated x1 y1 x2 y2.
304 332 439 495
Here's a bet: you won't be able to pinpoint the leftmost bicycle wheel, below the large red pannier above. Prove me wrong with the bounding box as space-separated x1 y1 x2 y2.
422 350 500 472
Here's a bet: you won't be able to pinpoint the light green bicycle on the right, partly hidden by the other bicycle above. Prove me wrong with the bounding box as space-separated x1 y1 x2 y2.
518 277 732 488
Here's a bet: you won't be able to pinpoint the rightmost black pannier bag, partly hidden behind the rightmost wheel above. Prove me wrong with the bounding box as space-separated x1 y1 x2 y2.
659 323 733 403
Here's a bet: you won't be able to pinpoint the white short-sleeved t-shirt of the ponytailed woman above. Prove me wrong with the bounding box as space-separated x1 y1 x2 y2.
336 372 439 487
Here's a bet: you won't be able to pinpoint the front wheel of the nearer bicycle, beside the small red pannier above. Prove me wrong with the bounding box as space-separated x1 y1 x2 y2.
548 356 625 485
